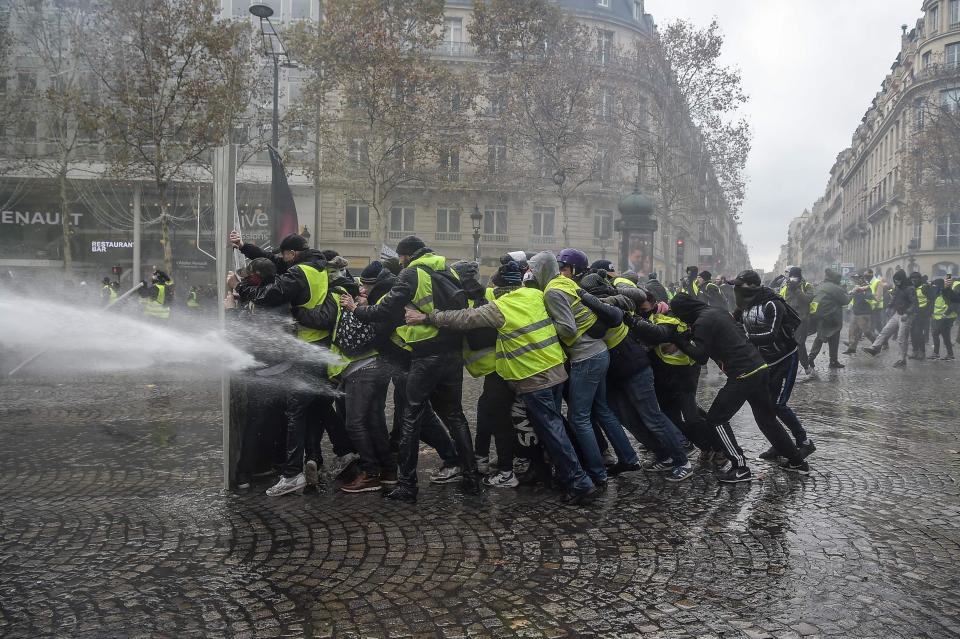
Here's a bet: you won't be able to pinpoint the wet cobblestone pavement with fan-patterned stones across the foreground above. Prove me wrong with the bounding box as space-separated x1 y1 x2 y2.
0 356 960 639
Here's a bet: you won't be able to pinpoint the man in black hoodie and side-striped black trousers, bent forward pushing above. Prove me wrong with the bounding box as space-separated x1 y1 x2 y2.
670 294 810 483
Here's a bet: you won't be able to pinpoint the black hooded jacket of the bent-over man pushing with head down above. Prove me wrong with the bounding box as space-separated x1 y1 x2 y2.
670 294 764 378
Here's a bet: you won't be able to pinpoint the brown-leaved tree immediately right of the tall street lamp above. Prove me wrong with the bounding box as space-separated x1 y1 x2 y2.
291 0 468 253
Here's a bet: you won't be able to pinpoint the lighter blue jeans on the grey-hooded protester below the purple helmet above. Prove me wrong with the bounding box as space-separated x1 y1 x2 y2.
567 351 637 481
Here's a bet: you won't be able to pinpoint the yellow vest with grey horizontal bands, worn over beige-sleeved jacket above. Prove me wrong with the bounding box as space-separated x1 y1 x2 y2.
490 288 566 381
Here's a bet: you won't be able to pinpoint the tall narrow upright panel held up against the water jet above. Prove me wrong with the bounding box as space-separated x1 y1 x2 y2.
213 144 237 490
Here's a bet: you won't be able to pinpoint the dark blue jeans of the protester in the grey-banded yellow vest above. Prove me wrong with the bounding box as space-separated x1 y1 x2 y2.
517 384 602 491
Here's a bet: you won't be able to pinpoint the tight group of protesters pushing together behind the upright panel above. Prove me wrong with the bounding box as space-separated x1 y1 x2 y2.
224 233 826 503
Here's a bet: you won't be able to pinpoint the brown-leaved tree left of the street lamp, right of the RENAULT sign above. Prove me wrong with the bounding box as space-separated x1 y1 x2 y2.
77 0 253 270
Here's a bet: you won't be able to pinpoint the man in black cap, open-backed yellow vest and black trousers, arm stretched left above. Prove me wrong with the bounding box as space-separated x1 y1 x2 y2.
352 235 482 502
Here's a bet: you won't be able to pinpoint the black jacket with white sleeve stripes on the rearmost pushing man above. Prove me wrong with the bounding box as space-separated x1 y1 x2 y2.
733 286 799 364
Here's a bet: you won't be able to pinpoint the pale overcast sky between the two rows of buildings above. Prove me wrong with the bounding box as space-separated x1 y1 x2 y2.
646 0 921 270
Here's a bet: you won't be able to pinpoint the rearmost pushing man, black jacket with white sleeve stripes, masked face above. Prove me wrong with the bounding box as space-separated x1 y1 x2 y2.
733 270 816 460
